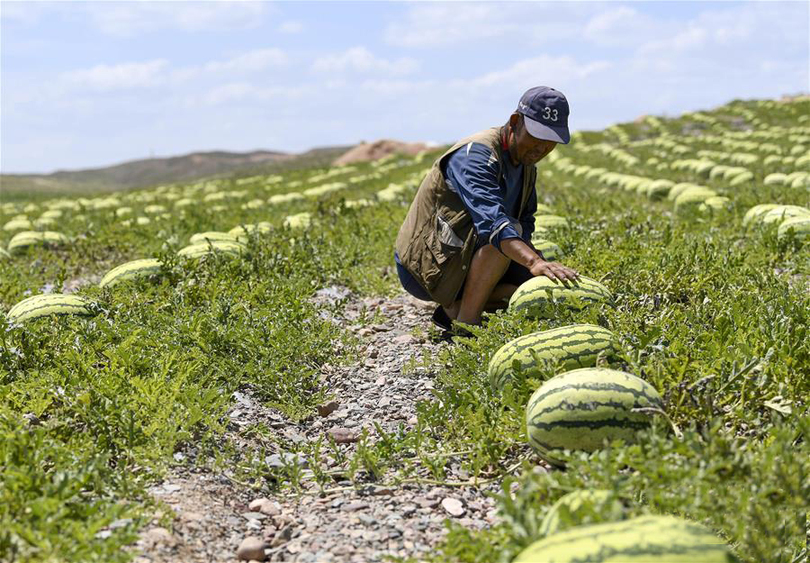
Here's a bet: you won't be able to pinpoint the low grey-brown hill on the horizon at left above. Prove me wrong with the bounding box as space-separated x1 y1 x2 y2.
0 146 352 197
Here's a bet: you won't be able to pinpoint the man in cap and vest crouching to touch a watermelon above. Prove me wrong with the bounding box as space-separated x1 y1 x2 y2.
394 86 579 336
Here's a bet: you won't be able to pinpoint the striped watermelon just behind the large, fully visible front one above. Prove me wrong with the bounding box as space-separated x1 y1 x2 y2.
487 324 616 389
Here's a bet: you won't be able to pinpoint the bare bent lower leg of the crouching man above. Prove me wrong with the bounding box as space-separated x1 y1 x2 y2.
448 244 517 325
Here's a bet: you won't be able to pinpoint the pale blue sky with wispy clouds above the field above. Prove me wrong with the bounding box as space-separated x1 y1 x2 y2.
0 0 810 173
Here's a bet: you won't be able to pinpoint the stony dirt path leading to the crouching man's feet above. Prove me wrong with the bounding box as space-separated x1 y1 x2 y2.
135 288 497 563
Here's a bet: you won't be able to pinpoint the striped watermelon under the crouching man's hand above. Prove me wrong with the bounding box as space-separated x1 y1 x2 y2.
509 276 613 318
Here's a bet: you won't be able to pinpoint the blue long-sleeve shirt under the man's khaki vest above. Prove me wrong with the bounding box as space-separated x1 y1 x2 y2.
443 143 537 251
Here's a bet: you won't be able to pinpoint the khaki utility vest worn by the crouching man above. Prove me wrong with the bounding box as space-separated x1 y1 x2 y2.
396 127 537 307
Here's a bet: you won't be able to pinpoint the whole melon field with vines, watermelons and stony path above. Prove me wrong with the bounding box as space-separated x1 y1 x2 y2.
0 97 810 563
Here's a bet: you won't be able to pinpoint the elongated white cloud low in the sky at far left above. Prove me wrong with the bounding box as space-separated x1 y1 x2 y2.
62 59 169 91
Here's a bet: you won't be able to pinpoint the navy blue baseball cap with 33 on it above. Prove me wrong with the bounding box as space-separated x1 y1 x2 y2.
517 86 571 145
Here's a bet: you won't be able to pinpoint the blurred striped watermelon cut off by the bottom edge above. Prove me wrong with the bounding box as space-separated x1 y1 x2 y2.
513 516 737 563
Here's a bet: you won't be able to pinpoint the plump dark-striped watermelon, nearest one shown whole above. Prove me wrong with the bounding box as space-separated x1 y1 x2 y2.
526 368 663 464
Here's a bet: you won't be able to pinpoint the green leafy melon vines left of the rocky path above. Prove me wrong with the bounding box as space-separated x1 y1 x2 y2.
0 153 430 562
